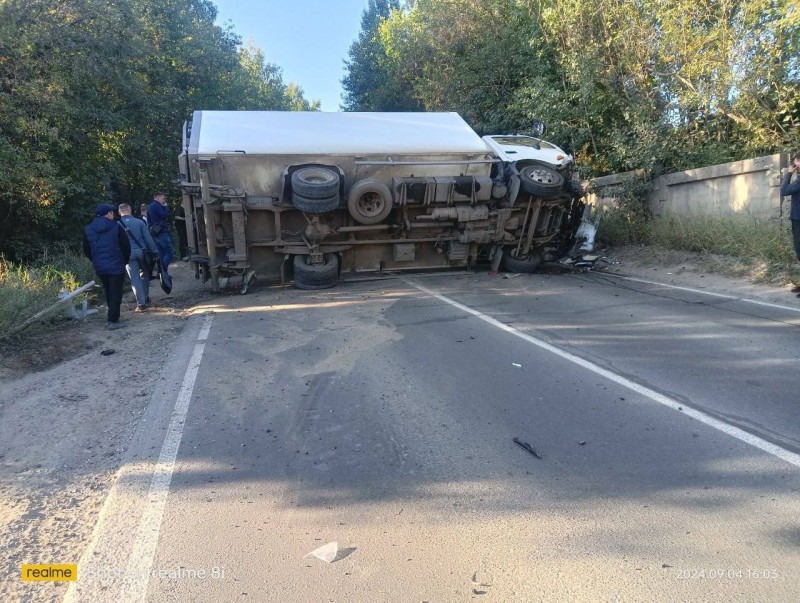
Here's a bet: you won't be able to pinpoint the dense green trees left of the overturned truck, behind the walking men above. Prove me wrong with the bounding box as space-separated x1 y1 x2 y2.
0 0 319 260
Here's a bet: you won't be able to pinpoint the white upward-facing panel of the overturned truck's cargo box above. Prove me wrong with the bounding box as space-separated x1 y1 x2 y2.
188 111 489 155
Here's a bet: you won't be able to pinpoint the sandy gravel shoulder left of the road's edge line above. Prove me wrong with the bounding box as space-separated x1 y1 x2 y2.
0 263 211 601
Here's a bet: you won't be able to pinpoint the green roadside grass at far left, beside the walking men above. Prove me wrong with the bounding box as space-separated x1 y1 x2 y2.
0 248 94 338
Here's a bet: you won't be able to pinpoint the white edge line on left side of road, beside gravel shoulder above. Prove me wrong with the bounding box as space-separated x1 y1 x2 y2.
122 314 214 602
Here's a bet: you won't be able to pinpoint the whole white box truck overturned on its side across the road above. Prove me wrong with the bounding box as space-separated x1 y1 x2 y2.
179 111 583 293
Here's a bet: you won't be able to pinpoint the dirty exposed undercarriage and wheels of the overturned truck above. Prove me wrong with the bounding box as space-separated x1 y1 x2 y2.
180 114 583 292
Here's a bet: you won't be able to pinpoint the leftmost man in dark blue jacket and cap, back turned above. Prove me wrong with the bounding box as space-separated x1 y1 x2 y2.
83 203 131 329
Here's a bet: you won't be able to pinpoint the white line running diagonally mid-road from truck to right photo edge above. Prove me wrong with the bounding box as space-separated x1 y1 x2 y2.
403 279 800 467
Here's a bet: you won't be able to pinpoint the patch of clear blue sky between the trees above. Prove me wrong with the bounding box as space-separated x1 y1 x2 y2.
213 0 368 111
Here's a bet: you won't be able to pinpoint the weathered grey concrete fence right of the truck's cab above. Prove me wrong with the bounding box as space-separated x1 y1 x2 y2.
588 154 789 219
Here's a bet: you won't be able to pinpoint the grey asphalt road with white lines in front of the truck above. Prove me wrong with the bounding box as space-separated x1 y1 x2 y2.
68 274 800 602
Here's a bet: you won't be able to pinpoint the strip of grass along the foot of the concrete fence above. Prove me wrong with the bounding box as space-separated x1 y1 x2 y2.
598 210 800 285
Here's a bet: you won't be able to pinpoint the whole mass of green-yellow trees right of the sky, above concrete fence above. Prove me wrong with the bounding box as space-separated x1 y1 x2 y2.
345 0 800 176
